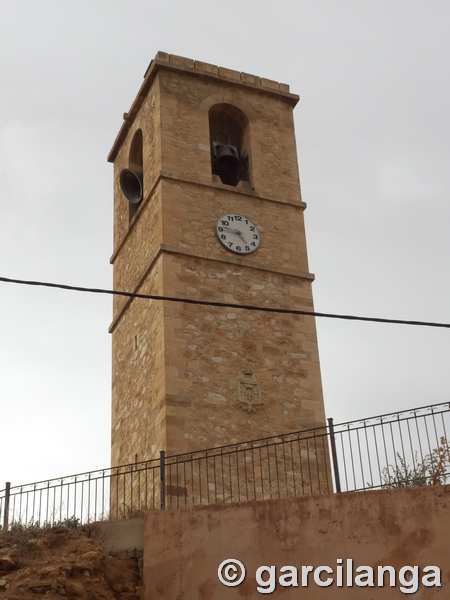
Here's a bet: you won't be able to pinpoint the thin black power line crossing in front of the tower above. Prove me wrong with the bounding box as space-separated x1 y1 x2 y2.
0 277 450 329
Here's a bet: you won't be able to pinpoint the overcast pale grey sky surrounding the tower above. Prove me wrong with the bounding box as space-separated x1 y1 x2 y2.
0 0 450 489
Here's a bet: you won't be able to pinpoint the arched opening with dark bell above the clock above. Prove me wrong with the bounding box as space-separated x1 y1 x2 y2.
209 104 250 186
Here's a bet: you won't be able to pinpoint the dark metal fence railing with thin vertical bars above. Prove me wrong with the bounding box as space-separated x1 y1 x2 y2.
0 403 450 527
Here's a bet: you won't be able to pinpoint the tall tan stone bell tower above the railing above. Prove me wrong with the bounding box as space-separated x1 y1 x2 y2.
108 52 325 466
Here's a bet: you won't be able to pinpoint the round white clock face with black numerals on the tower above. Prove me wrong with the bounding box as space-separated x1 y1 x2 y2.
216 213 260 254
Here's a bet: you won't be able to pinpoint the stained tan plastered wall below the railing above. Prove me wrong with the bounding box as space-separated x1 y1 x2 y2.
144 486 450 600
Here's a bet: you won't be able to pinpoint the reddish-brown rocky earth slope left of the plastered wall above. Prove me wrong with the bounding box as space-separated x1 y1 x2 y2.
0 527 143 600
